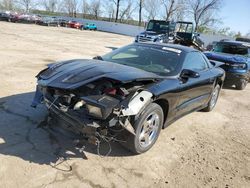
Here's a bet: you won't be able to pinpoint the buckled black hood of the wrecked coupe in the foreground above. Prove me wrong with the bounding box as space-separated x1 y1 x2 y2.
37 60 161 89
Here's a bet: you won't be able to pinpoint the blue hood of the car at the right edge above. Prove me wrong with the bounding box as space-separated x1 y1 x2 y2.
204 52 248 63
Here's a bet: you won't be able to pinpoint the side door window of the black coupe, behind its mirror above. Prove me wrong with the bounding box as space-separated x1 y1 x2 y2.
183 52 208 71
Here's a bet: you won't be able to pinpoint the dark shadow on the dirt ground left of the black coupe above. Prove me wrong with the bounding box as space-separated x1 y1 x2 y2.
0 92 132 164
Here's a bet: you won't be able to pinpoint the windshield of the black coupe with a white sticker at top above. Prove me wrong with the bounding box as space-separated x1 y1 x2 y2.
102 45 184 76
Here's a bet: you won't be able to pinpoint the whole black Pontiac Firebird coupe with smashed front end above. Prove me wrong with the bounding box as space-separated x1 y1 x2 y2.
32 43 225 154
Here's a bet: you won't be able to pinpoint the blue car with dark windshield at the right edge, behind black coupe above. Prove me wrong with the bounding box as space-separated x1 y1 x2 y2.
205 41 250 90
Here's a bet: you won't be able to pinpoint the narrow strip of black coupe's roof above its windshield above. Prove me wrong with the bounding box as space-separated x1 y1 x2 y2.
136 42 199 53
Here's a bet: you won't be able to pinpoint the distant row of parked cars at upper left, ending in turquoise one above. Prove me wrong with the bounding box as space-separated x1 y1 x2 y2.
0 12 97 31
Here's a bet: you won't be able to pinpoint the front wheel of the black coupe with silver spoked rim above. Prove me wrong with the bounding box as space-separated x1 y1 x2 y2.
123 103 164 154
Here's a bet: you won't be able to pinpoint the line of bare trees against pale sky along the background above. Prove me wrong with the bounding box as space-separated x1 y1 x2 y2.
0 0 246 34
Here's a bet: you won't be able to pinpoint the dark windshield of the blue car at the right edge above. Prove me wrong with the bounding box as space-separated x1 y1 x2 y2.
214 43 250 56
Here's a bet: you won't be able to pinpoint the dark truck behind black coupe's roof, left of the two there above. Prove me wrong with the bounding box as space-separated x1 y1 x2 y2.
135 20 175 43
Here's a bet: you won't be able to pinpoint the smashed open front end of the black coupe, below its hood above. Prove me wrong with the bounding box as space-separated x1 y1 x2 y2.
32 78 155 147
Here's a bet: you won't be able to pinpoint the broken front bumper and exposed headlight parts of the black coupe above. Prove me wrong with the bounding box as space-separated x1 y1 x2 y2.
32 85 153 137
